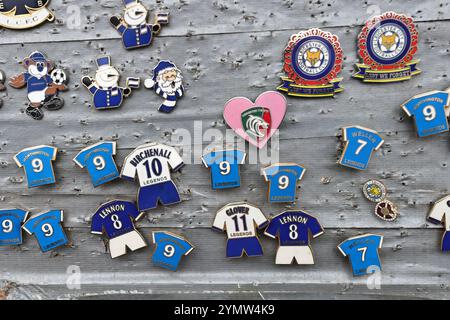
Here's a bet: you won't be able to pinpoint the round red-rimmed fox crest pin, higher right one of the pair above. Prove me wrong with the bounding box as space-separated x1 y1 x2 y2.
353 12 421 83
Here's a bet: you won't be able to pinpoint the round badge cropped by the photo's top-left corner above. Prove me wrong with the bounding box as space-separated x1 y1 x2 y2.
0 0 55 29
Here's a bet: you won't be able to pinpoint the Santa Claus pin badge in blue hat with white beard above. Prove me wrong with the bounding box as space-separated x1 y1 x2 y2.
144 60 184 113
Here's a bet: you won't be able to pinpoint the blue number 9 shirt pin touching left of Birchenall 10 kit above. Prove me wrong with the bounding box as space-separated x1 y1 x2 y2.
73 141 120 187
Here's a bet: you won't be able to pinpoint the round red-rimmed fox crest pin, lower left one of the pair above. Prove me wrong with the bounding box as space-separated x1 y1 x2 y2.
277 28 344 98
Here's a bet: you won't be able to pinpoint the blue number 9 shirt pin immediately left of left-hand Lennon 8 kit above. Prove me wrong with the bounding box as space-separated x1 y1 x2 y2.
22 210 69 252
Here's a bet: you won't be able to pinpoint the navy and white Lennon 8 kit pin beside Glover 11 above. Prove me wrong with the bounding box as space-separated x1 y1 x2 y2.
264 210 324 265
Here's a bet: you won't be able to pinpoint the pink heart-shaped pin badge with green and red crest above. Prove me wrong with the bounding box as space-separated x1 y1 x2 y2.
223 91 287 149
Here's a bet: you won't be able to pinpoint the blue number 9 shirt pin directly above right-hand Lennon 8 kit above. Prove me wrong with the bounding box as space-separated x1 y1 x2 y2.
261 163 306 202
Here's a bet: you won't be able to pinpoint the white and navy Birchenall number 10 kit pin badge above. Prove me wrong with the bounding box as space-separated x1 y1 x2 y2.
121 143 184 211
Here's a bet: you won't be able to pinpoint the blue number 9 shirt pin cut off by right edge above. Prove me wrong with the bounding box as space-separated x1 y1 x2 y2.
401 90 450 138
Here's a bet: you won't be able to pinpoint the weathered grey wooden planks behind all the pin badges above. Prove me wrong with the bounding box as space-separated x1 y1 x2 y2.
0 0 450 299
